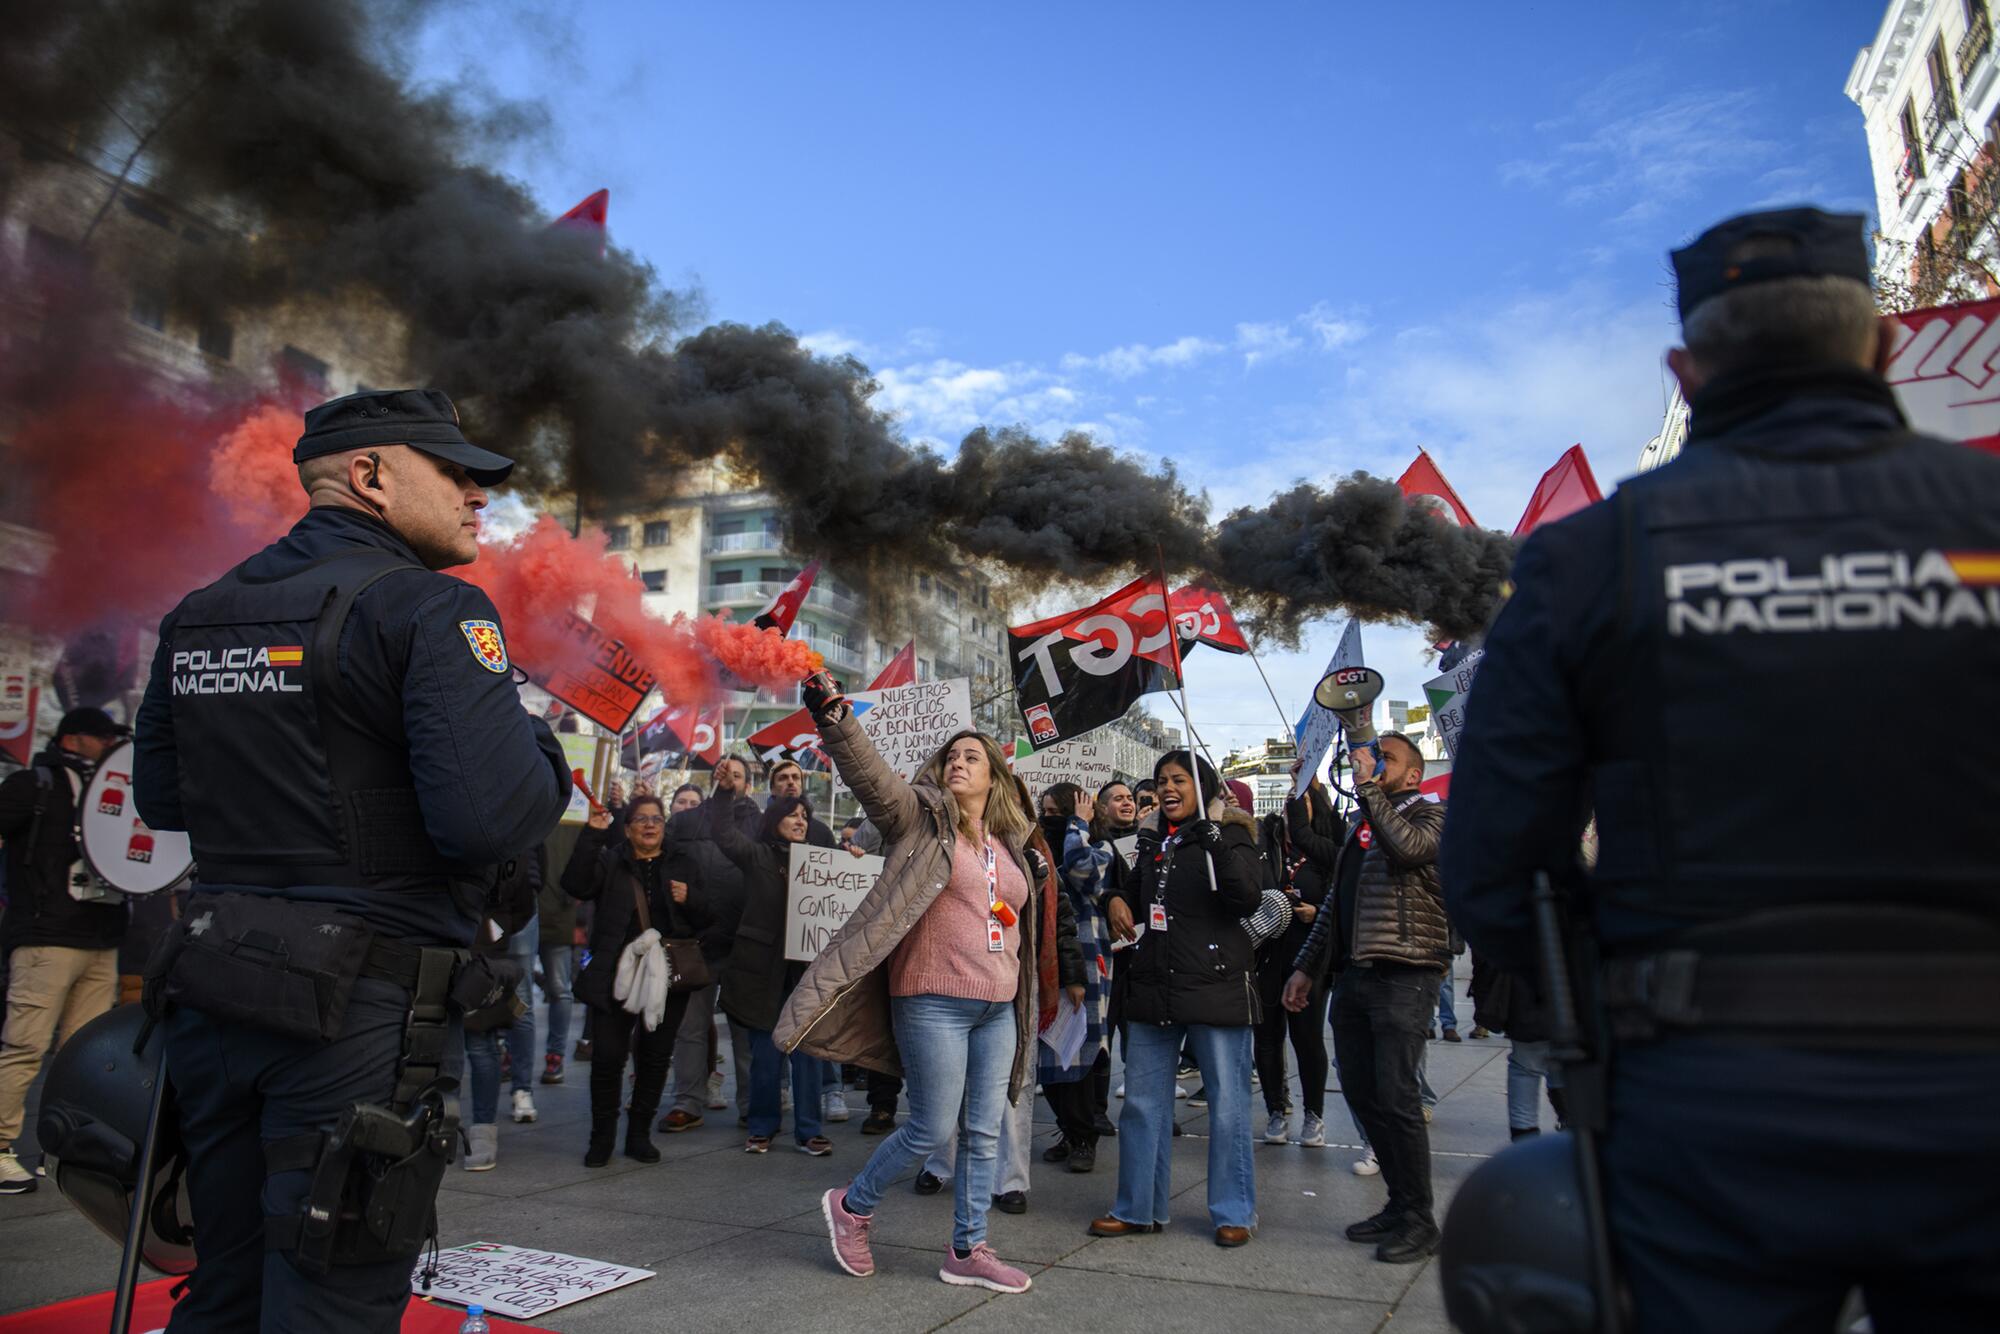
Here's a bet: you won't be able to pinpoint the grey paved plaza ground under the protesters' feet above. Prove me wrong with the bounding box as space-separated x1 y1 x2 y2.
0 982 1504 1334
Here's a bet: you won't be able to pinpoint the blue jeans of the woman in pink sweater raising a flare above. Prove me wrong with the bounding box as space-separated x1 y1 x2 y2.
844 996 1016 1250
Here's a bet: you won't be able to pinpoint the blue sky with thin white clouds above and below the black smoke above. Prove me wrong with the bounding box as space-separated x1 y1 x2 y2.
420 0 1882 746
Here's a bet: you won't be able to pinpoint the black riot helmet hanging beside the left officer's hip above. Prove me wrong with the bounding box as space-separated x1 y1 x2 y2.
36 1004 194 1274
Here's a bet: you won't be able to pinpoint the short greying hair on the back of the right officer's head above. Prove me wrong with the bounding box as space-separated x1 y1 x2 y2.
1682 236 1880 374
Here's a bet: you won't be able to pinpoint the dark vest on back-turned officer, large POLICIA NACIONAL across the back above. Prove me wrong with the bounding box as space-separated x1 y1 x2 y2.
1594 432 2000 944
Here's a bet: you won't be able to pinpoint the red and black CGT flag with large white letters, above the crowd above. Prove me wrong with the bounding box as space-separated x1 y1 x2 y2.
1008 574 1180 746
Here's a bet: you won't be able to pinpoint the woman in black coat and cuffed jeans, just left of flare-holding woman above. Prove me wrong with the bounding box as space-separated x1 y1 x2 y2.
708 796 836 1158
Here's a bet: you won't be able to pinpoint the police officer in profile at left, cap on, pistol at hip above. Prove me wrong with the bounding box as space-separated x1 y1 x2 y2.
134 390 570 1334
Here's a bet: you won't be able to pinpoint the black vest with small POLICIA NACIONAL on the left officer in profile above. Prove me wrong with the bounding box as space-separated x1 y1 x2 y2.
168 548 450 890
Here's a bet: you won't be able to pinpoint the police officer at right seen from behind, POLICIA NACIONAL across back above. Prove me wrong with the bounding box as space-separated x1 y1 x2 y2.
1444 208 2000 1334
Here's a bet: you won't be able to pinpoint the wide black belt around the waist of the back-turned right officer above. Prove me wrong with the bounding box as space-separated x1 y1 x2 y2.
1602 950 2000 1050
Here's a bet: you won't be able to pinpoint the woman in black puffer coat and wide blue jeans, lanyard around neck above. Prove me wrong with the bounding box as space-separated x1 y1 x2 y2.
1090 750 1264 1246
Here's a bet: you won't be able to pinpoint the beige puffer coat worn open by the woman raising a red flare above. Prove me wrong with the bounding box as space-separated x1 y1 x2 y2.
772 714 1042 1102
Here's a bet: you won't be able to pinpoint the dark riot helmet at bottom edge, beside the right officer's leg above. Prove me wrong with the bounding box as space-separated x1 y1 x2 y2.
1438 1134 1600 1334
